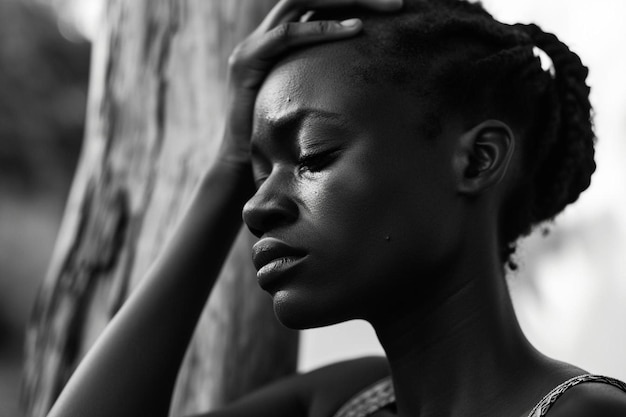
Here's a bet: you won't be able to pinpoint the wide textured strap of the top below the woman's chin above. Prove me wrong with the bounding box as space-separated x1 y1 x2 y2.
334 377 396 417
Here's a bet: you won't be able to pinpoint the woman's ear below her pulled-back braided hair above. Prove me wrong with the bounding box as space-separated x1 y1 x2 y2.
454 120 515 195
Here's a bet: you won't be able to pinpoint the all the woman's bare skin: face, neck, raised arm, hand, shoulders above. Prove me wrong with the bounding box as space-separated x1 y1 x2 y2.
42 0 626 417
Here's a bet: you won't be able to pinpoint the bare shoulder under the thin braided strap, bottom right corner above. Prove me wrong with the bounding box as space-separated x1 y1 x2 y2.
547 376 626 417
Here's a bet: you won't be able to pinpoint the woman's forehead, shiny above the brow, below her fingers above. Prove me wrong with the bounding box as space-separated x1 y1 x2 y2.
255 42 415 133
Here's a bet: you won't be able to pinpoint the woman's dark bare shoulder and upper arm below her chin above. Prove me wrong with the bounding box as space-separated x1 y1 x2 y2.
184 357 389 417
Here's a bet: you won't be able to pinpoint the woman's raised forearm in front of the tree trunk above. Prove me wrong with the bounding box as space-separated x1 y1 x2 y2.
49 157 252 417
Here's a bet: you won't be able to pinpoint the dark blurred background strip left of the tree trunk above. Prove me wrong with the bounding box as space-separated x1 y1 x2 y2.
0 0 90 417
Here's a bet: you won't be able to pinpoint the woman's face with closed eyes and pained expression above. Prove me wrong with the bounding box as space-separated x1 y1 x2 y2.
243 43 460 328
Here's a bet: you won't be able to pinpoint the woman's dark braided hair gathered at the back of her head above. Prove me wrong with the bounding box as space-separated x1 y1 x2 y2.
315 0 596 269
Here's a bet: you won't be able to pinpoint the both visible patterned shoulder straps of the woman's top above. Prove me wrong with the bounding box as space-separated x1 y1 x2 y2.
334 374 626 417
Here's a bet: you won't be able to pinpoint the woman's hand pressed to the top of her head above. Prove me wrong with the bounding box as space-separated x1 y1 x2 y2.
220 0 402 165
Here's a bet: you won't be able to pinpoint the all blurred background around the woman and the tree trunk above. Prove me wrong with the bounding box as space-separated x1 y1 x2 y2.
0 0 626 417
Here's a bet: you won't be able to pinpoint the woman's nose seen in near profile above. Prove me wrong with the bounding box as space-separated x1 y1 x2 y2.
242 171 298 237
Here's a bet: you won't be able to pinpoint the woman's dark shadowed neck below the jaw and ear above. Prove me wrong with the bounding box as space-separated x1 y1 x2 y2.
371 245 541 417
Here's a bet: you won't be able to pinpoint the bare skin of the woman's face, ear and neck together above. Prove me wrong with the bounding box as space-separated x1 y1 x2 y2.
243 41 582 416
